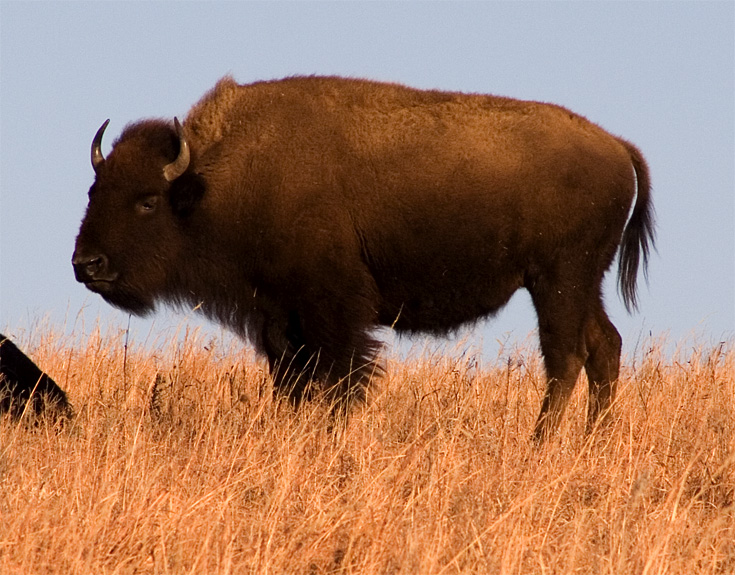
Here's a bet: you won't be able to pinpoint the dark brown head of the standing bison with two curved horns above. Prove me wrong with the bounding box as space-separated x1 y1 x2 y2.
72 119 204 314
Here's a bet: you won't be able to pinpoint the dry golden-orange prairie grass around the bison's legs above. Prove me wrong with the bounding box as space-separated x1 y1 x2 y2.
0 326 735 574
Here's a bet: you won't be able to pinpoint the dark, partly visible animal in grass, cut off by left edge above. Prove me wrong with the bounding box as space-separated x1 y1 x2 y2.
0 334 72 418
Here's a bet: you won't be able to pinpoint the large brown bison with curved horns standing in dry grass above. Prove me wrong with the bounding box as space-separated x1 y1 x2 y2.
73 77 653 439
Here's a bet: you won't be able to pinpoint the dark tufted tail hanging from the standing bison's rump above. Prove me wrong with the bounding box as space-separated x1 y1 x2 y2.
618 140 655 313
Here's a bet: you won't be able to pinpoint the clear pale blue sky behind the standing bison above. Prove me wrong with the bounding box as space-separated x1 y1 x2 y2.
0 1 735 355
